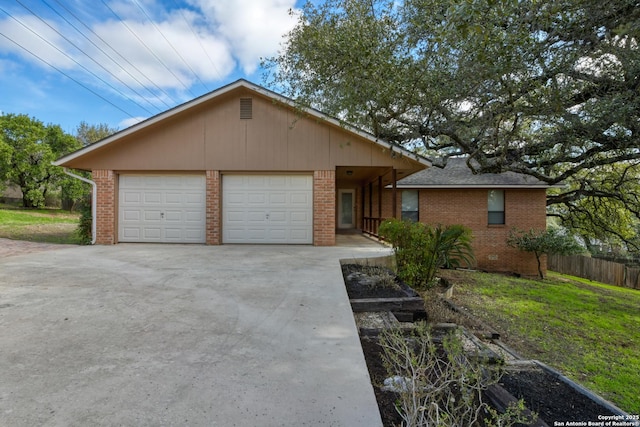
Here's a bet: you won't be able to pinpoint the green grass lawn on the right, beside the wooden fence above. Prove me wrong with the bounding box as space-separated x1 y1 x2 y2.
443 271 640 414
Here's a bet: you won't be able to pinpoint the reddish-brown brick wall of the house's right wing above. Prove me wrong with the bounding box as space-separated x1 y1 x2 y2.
383 189 546 276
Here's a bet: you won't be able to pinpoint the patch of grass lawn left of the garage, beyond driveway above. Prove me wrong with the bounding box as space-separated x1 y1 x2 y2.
0 205 80 244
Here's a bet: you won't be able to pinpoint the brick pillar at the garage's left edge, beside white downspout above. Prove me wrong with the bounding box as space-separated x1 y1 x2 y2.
92 170 116 245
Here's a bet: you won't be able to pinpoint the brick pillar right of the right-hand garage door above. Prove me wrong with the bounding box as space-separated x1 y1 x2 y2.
313 170 336 246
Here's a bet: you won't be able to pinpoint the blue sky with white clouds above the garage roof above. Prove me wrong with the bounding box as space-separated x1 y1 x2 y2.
0 0 302 134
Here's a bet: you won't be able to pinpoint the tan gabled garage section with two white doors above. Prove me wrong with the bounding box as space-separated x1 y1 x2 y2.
54 80 429 246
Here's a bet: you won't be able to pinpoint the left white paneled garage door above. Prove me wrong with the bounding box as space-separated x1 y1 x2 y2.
118 175 206 243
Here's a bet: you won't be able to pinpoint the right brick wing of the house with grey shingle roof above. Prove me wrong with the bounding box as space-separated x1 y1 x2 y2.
372 158 549 276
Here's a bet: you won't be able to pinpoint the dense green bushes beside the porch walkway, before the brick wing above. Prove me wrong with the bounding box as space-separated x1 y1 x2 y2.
378 219 474 288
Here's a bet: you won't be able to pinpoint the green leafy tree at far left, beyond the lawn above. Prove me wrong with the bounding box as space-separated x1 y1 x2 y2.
0 114 78 207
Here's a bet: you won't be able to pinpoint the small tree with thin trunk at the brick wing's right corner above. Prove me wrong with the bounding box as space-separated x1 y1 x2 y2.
507 228 584 279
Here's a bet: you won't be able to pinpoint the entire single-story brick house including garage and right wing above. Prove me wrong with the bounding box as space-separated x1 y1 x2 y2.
54 80 546 275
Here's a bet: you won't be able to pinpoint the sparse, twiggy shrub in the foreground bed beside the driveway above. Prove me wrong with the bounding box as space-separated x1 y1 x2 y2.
379 323 536 427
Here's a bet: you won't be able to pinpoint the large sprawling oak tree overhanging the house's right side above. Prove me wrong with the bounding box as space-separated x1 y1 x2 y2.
265 0 640 251
